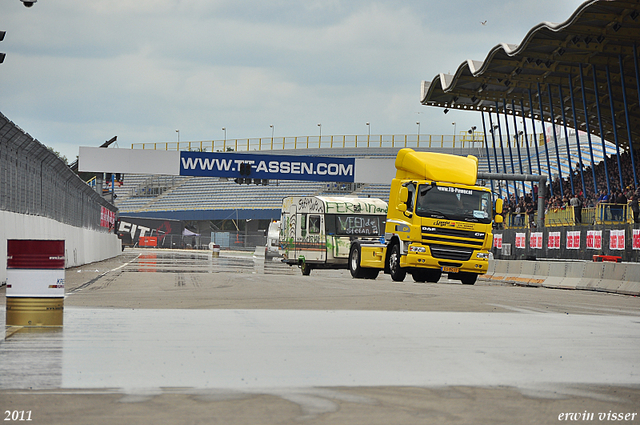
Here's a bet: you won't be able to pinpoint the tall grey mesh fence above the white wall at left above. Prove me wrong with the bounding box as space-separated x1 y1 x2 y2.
0 109 117 231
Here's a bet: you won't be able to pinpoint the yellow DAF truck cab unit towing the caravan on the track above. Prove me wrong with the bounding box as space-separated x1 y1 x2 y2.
349 149 502 285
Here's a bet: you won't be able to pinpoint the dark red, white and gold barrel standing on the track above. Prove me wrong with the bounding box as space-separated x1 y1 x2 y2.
6 239 65 326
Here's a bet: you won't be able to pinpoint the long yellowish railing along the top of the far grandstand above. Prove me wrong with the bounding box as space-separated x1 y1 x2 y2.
131 133 539 152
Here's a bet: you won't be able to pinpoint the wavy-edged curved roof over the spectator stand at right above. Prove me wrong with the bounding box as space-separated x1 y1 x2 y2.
421 0 640 150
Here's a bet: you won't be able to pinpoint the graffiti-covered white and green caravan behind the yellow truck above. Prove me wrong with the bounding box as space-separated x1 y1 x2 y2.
280 196 387 275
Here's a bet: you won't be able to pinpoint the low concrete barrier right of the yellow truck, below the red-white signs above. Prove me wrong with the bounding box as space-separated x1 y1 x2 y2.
480 260 640 295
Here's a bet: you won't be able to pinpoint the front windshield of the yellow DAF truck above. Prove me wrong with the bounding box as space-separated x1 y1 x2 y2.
416 184 492 223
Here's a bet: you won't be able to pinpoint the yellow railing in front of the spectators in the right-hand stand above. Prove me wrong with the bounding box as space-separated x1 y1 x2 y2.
504 203 633 229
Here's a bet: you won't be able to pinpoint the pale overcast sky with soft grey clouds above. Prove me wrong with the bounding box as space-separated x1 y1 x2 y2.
0 0 582 160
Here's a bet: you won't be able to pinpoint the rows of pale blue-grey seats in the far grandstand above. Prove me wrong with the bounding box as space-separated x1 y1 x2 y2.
116 138 615 219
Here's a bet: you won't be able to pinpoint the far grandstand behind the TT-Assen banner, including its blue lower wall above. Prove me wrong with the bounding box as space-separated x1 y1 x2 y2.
115 133 616 229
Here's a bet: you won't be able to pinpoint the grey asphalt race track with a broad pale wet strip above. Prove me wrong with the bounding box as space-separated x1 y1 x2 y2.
0 250 640 423
